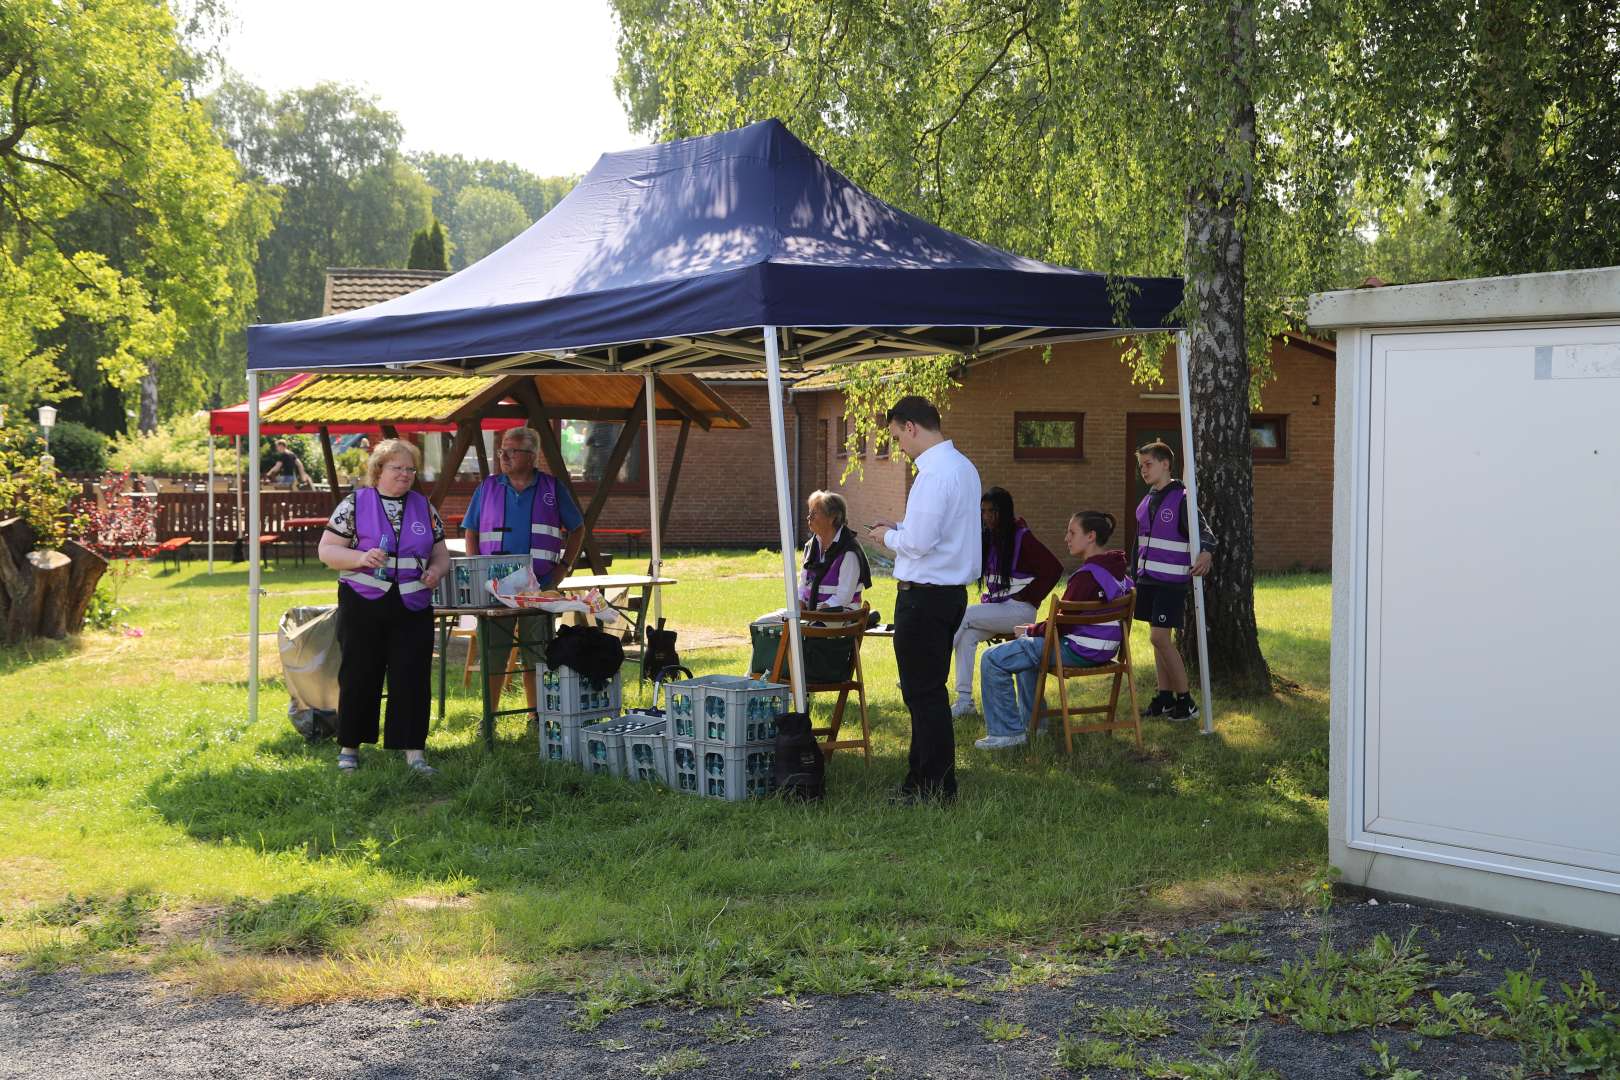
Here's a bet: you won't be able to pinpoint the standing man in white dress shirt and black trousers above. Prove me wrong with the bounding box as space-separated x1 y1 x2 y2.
868 397 980 803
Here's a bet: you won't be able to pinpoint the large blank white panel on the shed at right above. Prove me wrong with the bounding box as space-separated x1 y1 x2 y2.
1362 327 1620 871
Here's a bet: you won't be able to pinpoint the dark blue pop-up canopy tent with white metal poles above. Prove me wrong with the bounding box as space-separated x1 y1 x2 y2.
248 120 1209 738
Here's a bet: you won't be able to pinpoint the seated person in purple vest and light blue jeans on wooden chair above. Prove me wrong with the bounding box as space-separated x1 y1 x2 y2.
974 510 1134 750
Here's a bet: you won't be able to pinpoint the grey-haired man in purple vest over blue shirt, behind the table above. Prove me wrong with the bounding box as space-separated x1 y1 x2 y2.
462 427 585 709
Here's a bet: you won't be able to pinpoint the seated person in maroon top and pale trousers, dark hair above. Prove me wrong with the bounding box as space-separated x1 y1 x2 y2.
951 487 1063 716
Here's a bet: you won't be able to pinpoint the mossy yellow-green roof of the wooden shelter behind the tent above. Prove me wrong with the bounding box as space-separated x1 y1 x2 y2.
264 372 748 431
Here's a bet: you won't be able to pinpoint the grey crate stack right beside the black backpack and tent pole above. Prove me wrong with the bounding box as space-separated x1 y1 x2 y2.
669 675 789 801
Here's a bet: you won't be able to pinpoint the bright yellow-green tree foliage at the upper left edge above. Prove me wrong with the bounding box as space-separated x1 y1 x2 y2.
0 0 271 430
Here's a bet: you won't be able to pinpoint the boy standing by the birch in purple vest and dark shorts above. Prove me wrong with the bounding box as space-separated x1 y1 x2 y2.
1131 442 1215 721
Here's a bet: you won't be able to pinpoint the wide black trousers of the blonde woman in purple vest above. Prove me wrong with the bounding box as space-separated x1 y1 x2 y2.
337 585 433 750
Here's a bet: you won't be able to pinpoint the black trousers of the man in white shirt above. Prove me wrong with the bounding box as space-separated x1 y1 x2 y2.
894 585 967 795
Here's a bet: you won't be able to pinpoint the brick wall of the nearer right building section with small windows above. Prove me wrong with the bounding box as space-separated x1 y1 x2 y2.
795 342 1333 570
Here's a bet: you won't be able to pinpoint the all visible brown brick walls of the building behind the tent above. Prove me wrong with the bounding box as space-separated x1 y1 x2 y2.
430 342 1333 570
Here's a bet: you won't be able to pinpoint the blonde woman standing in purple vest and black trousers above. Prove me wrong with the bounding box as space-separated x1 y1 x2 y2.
319 439 450 776
